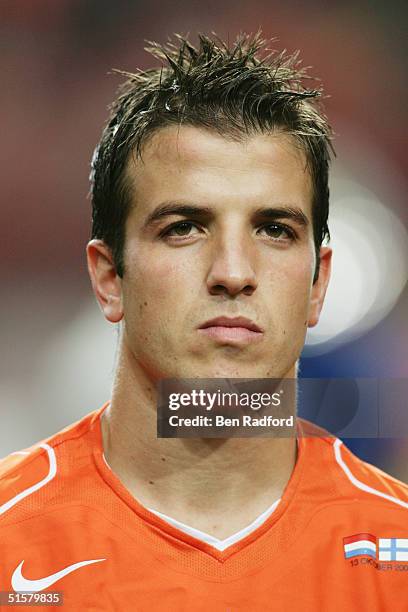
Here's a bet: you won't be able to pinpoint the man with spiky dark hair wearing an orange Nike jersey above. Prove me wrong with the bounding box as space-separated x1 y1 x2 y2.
0 35 408 612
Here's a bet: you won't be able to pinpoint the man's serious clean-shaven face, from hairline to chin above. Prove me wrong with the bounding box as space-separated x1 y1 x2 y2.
103 126 332 379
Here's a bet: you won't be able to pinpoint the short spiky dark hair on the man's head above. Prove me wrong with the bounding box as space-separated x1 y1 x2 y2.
91 31 333 278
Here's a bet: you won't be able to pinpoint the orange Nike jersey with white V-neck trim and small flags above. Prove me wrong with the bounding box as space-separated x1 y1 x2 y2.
0 405 408 612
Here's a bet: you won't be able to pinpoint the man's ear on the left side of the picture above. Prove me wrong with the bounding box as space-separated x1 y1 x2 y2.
86 240 123 323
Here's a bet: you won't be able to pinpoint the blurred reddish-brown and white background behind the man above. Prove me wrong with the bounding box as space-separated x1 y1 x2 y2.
0 0 408 481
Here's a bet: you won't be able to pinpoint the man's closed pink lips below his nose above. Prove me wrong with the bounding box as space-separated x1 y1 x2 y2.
199 317 263 344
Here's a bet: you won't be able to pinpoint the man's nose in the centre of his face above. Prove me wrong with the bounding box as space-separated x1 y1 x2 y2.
207 232 257 297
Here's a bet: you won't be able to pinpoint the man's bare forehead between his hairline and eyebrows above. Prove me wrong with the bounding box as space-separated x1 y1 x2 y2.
127 126 312 214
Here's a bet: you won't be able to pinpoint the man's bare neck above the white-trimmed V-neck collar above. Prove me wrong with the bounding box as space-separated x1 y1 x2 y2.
102 342 296 539
